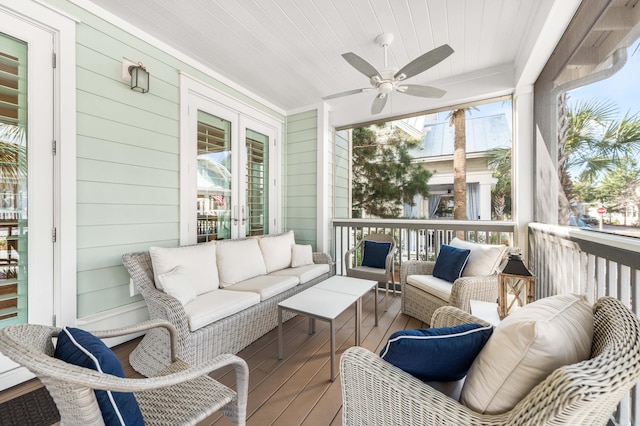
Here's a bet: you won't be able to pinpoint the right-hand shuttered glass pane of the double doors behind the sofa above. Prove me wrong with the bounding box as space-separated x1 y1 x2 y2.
245 129 269 235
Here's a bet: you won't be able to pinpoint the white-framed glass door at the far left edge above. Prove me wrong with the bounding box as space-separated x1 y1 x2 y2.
0 13 55 380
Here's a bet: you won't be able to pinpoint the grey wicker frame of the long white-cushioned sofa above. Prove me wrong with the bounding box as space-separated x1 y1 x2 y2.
122 251 335 376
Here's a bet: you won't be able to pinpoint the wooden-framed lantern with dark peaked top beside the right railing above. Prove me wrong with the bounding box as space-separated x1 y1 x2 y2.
498 253 536 319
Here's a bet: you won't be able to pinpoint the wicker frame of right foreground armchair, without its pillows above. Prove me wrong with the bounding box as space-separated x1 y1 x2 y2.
340 297 640 426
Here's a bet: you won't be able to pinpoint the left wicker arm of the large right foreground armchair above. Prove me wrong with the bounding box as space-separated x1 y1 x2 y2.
340 346 507 426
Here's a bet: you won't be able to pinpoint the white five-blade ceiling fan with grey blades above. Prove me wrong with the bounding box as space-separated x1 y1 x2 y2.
322 33 453 114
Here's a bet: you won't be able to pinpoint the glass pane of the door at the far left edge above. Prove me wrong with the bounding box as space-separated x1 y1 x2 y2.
0 34 27 327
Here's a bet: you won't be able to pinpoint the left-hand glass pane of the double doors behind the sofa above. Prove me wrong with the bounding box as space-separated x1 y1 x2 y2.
197 111 232 243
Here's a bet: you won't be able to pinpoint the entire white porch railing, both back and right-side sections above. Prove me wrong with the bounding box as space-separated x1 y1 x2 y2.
332 219 640 425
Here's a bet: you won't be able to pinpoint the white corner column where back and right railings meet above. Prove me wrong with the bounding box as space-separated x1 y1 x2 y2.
512 85 535 255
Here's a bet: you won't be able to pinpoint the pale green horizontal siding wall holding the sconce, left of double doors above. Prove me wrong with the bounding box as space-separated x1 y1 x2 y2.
36 0 284 317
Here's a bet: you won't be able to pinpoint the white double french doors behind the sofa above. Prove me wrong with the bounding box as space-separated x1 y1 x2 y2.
181 75 278 244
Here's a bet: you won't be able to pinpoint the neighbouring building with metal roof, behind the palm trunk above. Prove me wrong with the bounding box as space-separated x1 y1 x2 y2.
405 114 511 220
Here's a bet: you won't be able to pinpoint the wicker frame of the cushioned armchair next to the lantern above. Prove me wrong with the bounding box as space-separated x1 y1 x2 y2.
400 260 498 324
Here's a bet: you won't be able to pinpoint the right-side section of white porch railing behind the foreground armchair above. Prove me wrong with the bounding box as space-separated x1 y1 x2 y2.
529 223 640 425
